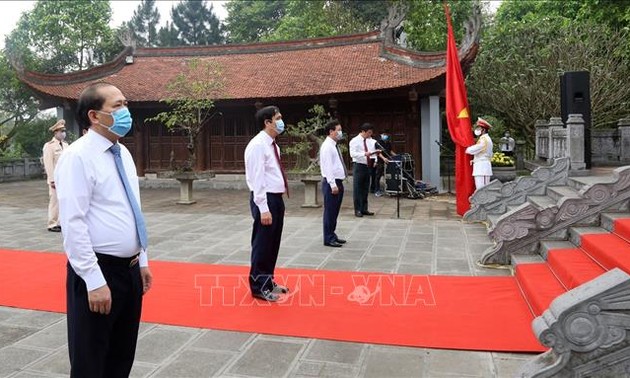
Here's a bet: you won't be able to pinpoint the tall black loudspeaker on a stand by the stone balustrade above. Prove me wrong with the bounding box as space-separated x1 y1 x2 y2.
560 71 591 169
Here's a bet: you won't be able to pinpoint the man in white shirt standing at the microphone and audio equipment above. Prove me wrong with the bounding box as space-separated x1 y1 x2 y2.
350 123 381 217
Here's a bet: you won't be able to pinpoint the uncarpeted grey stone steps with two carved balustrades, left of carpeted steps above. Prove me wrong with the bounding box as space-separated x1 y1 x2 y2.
464 162 630 265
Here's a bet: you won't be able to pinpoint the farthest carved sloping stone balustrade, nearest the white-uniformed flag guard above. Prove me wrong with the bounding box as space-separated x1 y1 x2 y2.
464 158 569 222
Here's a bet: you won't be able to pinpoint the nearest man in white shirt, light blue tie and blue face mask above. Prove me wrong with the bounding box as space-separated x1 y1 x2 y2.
55 83 153 377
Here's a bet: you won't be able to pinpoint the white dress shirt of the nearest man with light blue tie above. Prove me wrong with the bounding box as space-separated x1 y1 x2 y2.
55 131 148 291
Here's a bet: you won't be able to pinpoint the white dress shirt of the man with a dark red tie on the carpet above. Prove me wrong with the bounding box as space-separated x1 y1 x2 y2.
245 130 284 213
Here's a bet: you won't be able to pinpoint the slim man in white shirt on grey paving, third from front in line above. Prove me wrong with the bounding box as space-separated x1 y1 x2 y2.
319 119 346 247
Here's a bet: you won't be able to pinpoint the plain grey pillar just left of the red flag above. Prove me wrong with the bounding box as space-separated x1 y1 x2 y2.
420 96 442 192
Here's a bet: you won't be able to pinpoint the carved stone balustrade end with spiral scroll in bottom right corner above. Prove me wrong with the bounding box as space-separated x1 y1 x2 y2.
517 268 630 378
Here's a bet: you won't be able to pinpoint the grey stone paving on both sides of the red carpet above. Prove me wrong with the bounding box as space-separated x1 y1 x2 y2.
0 180 532 377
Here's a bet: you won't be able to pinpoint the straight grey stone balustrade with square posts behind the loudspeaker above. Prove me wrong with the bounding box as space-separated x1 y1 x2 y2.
535 114 630 170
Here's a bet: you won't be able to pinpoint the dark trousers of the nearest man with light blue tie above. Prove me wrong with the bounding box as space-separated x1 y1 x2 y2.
66 261 142 378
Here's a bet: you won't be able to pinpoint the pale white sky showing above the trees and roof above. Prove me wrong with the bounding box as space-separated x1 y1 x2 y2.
0 0 227 48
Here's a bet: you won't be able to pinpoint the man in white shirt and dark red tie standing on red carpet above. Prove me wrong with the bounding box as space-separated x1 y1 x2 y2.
245 106 289 302
